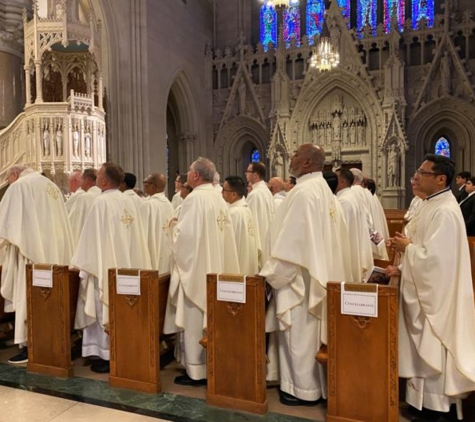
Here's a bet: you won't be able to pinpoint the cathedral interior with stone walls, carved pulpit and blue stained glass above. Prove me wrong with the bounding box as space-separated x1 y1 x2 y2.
0 0 475 204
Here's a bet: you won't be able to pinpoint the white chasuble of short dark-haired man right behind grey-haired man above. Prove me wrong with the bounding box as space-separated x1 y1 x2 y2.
229 198 259 275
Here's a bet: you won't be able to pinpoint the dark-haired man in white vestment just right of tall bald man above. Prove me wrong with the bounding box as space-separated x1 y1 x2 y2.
336 168 373 283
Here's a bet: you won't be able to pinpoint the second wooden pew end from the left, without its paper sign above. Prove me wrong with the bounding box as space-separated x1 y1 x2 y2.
109 269 170 393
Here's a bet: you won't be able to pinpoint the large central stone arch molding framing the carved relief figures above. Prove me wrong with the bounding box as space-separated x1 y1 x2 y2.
287 69 384 182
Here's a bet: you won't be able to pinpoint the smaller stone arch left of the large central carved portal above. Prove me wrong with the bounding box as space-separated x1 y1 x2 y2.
215 116 269 176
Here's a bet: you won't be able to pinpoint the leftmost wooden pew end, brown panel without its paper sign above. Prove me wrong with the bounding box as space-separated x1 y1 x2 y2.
26 264 80 378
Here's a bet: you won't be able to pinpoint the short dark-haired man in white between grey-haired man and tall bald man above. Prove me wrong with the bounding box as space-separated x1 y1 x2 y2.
222 176 259 275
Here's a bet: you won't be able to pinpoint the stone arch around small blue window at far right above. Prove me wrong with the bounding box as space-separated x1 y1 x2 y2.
406 97 475 179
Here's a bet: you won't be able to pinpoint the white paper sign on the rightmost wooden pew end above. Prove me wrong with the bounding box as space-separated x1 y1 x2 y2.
341 283 378 318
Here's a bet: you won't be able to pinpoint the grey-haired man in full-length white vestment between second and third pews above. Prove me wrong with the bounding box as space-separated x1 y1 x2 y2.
164 157 239 385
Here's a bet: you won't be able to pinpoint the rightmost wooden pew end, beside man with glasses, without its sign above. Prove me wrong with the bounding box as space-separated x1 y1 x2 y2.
326 283 399 422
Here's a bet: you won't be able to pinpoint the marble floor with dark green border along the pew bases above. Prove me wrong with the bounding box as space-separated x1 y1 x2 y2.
0 347 462 422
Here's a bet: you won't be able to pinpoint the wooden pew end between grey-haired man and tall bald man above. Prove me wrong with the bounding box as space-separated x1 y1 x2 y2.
202 274 267 414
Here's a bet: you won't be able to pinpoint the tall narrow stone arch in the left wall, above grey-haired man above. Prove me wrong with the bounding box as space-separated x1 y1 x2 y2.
167 68 203 171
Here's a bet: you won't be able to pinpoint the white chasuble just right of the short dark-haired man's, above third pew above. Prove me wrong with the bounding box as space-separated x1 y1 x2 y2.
246 180 275 268
